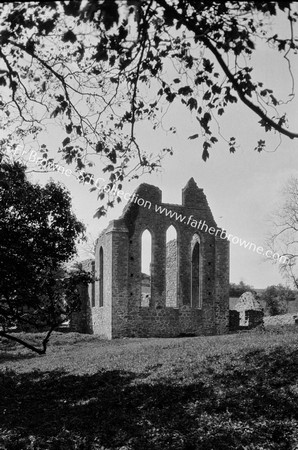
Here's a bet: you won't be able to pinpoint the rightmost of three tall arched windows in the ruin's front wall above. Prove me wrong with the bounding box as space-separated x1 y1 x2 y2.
191 234 202 308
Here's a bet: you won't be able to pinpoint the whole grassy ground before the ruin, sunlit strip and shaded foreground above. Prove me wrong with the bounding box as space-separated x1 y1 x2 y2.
0 326 298 450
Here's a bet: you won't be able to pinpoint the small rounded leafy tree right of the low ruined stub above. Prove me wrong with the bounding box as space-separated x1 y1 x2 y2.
260 284 295 316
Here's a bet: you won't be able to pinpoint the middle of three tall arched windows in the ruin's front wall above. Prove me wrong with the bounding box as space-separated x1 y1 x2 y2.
166 225 178 308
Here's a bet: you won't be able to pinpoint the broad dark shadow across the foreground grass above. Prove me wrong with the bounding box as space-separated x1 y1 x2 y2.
0 349 298 450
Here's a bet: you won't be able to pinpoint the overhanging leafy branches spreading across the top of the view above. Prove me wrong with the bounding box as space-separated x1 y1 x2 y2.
0 0 298 216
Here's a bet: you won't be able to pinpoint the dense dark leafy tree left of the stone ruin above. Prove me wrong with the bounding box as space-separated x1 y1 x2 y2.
0 156 90 354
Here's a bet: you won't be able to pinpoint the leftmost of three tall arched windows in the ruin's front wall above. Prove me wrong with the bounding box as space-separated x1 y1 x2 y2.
141 230 152 306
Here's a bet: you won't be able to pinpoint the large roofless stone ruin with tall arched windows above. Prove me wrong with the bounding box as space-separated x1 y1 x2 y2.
71 178 229 339
